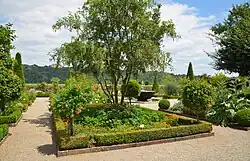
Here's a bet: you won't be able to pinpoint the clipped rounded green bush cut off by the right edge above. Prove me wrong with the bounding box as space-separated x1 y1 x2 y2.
234 108 250 126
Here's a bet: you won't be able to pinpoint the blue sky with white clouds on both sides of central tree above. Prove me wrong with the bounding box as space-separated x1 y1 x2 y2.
0 0 246 75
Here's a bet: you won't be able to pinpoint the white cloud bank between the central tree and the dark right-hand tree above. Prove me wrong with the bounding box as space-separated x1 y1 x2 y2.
161 3 216 74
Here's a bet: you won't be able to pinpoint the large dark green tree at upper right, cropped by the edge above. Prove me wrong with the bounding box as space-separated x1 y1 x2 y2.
208 3 250 76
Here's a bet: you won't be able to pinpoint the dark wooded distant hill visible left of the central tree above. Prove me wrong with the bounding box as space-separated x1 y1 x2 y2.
24 64 69 83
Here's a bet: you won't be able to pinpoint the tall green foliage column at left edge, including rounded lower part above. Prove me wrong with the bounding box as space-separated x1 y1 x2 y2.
0 24 23 112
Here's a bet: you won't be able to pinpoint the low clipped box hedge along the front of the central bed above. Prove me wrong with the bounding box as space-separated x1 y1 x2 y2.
53 107 212 155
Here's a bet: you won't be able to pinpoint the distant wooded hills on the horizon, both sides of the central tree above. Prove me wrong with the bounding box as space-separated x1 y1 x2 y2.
24 64 185 84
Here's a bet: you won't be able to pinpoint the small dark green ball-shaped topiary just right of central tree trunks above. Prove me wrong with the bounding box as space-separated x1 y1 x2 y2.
122 80 141 103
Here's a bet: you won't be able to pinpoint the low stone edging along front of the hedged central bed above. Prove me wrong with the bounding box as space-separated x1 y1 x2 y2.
56 131 214 157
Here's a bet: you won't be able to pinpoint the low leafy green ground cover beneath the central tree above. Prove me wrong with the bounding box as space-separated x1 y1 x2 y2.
75 105 165 128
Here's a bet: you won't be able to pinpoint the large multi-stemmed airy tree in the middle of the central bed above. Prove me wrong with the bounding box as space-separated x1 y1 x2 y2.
51 0 177 104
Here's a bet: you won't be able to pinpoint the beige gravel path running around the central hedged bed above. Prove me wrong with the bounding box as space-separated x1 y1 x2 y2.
0 98 250 161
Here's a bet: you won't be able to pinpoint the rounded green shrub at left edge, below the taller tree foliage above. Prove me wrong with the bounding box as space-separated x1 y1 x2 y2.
0 65 23 111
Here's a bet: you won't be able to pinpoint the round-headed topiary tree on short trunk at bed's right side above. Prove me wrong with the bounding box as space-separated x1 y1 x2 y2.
182 79 214 119
